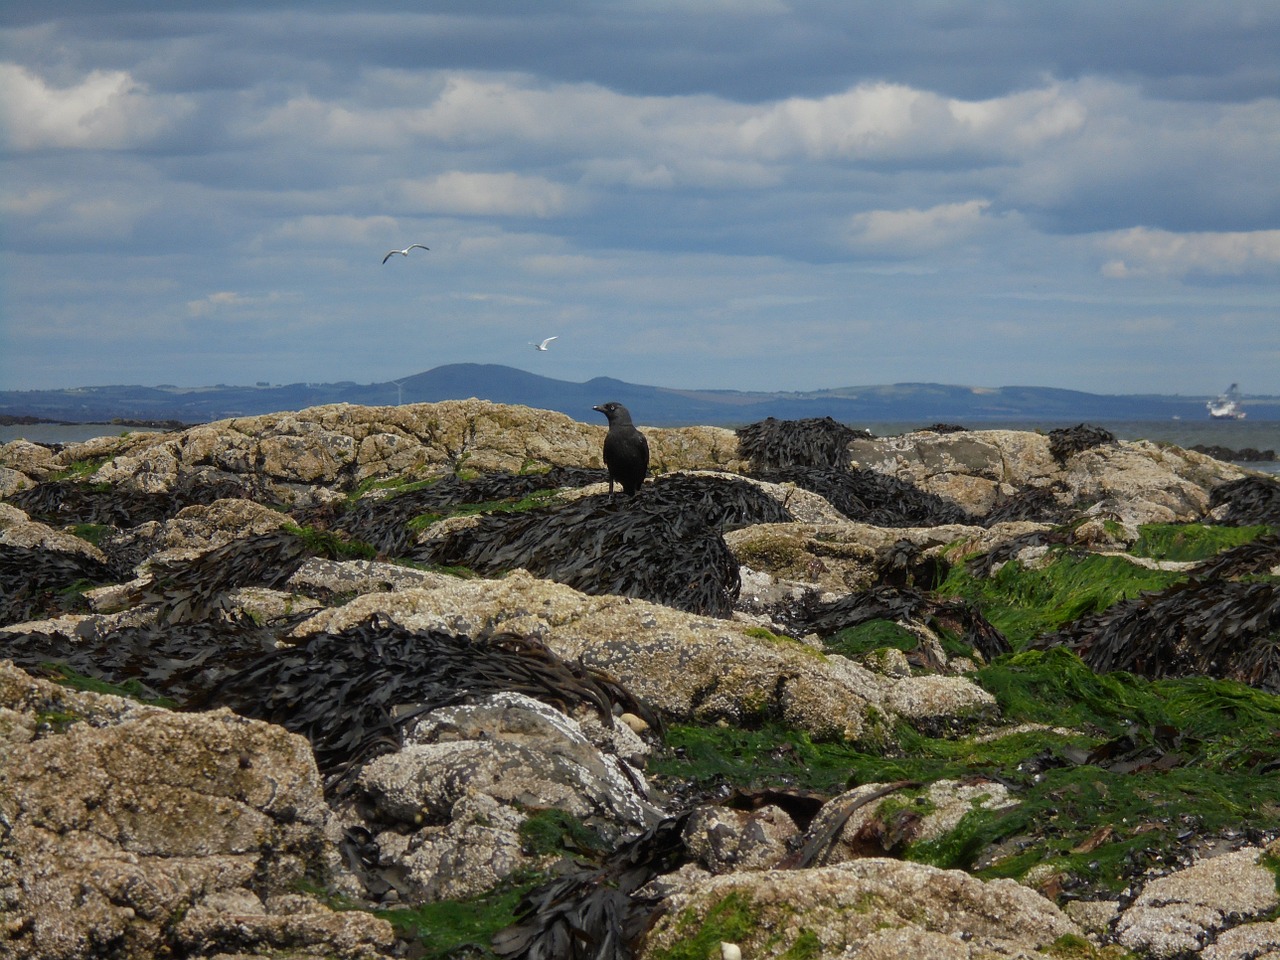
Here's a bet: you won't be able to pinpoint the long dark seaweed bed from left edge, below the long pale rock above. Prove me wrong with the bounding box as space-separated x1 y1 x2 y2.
0 614 662 790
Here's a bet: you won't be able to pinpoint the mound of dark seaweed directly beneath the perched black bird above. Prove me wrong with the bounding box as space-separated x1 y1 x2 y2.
408 475 794 617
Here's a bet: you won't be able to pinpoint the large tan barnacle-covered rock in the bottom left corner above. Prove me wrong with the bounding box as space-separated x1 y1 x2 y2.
0 662 390 960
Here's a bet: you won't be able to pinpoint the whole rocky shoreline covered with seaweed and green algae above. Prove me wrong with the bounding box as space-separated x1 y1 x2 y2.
0 401 1280 960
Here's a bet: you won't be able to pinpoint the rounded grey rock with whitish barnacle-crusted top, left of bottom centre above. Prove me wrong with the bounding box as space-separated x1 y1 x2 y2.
358 694 662 901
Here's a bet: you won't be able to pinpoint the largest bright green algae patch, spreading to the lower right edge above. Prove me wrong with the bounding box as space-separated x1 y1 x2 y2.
650 649 1280 893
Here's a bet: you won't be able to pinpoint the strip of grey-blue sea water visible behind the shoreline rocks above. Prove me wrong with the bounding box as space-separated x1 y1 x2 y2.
0 417 1280 475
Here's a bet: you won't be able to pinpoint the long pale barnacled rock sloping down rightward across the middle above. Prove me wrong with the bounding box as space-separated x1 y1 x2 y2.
294 571 967 744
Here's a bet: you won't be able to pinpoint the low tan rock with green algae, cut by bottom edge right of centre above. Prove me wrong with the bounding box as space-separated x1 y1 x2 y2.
640 858 1082 960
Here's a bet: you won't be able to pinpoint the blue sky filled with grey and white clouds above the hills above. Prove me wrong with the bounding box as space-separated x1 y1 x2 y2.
0 0 1280 396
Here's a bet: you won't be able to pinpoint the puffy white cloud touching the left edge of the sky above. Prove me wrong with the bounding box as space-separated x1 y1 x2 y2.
0 64 193 150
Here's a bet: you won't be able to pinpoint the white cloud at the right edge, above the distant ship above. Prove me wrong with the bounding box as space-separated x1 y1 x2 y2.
1098 227 1280 279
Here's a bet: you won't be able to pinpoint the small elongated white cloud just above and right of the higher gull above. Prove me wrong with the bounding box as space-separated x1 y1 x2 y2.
399 170 570 219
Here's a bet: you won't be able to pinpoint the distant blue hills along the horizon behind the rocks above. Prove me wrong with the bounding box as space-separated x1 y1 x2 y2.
0 364 1280 426
